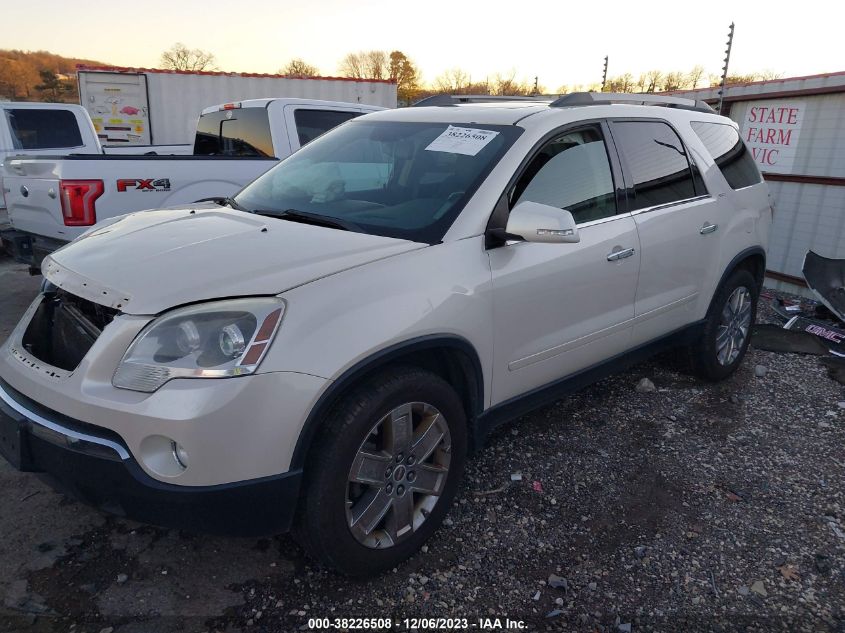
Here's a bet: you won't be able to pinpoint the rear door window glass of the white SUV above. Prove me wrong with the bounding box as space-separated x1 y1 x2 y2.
613 121 705 211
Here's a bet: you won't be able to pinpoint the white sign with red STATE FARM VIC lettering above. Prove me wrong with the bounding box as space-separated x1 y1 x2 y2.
742 101 806 174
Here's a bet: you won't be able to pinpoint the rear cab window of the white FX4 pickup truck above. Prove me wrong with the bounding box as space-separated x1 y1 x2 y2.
194 108 273 157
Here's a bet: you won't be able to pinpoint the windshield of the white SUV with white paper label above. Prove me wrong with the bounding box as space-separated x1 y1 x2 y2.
235 119 521 244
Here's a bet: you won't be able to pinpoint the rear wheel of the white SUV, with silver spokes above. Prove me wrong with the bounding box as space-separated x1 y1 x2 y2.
690 270 759 381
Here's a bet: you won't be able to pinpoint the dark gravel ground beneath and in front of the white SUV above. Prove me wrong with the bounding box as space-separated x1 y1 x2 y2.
0 266 845 633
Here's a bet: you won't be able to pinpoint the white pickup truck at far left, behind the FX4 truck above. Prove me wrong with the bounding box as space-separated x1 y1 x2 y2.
0 101 193 209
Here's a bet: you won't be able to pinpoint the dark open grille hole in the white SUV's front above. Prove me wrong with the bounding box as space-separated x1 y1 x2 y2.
22 288 118 371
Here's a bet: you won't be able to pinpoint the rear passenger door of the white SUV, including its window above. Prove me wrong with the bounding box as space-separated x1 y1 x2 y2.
610 119 724 345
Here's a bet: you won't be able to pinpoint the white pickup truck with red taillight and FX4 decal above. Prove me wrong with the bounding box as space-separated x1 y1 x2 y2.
0 98 384 267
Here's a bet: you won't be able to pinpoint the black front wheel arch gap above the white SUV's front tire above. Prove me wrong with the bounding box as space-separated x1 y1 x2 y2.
290 334 484 470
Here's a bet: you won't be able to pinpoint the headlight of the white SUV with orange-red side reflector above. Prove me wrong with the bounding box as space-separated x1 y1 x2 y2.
112 298 285 393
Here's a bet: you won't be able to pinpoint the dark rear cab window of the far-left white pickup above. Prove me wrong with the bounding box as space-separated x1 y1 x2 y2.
6 108 82 150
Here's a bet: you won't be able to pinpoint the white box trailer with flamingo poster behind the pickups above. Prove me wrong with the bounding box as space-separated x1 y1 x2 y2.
77 66 397 147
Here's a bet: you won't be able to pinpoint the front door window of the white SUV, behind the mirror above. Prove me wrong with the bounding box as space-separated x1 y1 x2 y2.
511 128 617 224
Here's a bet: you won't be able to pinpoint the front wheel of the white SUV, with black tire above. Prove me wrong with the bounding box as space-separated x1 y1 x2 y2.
294 367 467 576
